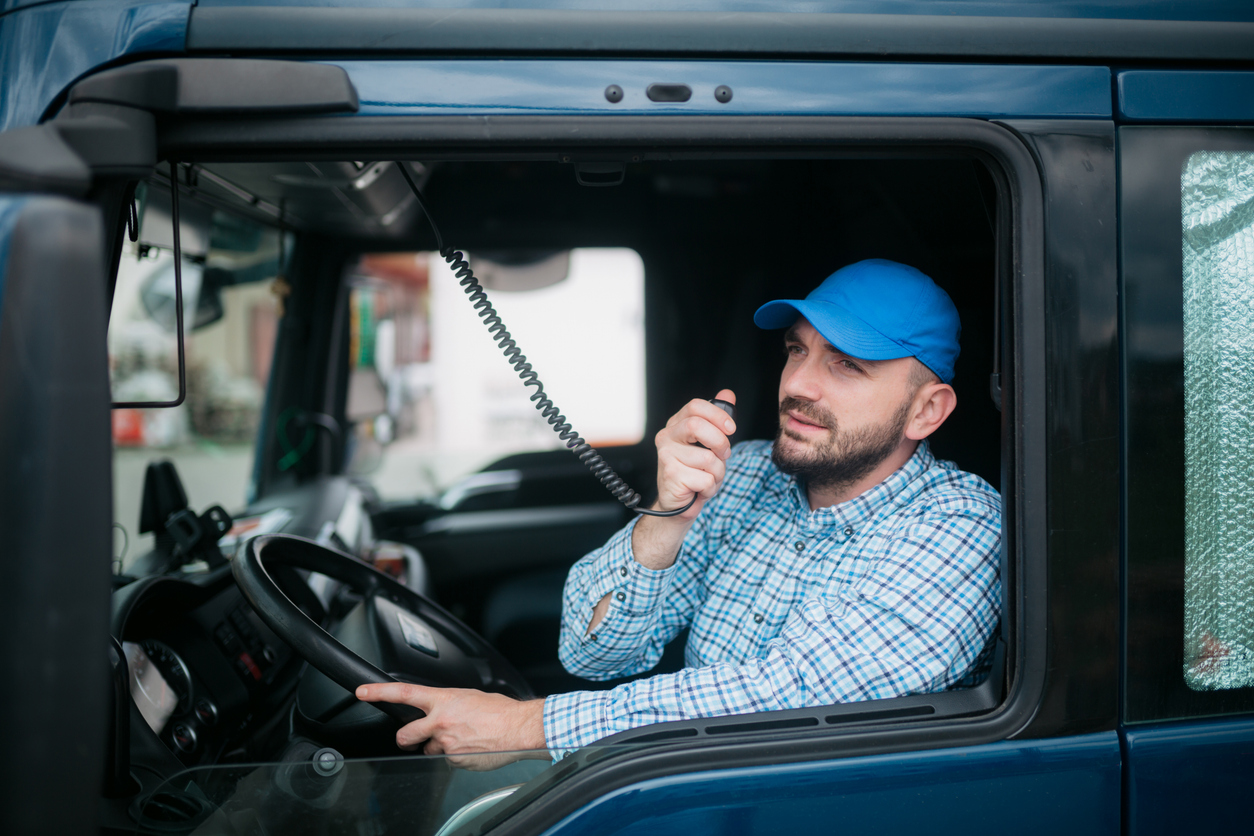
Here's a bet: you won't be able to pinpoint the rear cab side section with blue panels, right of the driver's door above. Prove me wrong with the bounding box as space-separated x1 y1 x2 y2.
1119 71 1254 835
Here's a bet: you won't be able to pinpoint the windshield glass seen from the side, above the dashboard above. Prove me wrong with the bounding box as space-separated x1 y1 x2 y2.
109 184 281 570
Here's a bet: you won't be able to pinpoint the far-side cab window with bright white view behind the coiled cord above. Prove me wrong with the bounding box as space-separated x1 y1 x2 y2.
346 248 645 499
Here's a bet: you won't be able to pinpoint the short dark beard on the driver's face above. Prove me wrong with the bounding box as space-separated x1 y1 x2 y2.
771 397 912 490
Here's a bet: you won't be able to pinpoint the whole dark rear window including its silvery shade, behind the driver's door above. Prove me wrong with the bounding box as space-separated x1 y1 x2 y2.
1121 128 1254 721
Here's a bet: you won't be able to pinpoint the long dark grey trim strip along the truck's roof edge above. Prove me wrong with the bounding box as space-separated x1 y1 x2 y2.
187 6 1254 63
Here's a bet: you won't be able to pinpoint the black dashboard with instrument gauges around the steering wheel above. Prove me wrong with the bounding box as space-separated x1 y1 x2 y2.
110 478 418 785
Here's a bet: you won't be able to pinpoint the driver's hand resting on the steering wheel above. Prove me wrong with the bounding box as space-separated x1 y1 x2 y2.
357 682 544 755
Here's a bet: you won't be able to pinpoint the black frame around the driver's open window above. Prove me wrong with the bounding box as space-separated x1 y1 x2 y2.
151 115 1048 833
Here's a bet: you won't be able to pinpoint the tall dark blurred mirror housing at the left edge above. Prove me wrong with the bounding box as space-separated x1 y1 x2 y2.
0 196 113 833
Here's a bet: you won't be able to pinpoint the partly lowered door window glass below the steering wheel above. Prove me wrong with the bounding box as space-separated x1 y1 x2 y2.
135 745 627 836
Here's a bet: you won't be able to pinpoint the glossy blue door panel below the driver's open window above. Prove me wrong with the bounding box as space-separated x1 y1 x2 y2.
549 732 1120 836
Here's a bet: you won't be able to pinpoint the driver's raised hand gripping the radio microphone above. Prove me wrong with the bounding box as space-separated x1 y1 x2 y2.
653 389 736 518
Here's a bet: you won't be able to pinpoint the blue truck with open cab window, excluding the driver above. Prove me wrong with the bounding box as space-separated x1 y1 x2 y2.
0 0 1254 836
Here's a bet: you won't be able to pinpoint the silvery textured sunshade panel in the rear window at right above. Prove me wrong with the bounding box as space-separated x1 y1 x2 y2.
1180 150 1254 691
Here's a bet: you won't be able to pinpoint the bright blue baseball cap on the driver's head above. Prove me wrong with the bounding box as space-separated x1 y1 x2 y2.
754 258 962 384
